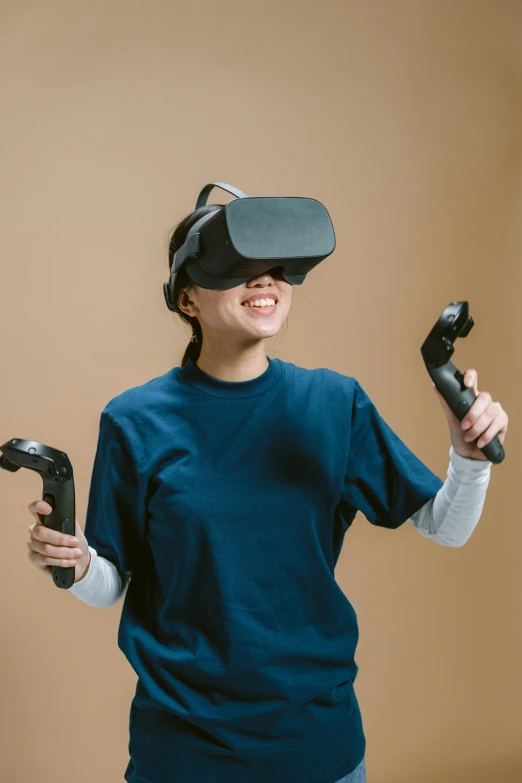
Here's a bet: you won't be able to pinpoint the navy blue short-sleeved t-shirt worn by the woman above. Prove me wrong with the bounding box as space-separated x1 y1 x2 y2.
85 357 443 783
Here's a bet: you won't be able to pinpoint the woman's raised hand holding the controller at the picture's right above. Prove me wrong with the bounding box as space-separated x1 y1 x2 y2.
433 370 508 460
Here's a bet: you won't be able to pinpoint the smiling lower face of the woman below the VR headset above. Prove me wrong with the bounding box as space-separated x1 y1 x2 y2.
179 269 293 338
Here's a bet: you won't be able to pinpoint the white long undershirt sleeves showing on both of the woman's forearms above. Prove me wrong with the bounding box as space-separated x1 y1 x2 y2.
69 446 493 608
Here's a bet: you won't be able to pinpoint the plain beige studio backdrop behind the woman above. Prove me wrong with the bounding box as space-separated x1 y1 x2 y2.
0 0 522 783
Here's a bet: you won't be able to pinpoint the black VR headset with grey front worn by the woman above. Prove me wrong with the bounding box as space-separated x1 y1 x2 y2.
163 182 335 313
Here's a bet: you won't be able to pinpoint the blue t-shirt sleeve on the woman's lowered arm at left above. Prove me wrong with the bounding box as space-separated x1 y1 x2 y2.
84 410 144 578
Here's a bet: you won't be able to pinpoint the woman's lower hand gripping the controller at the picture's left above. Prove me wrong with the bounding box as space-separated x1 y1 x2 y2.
27 499 91 584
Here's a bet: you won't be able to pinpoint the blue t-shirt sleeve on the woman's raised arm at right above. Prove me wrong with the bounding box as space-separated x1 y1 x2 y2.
341 380 444 528
